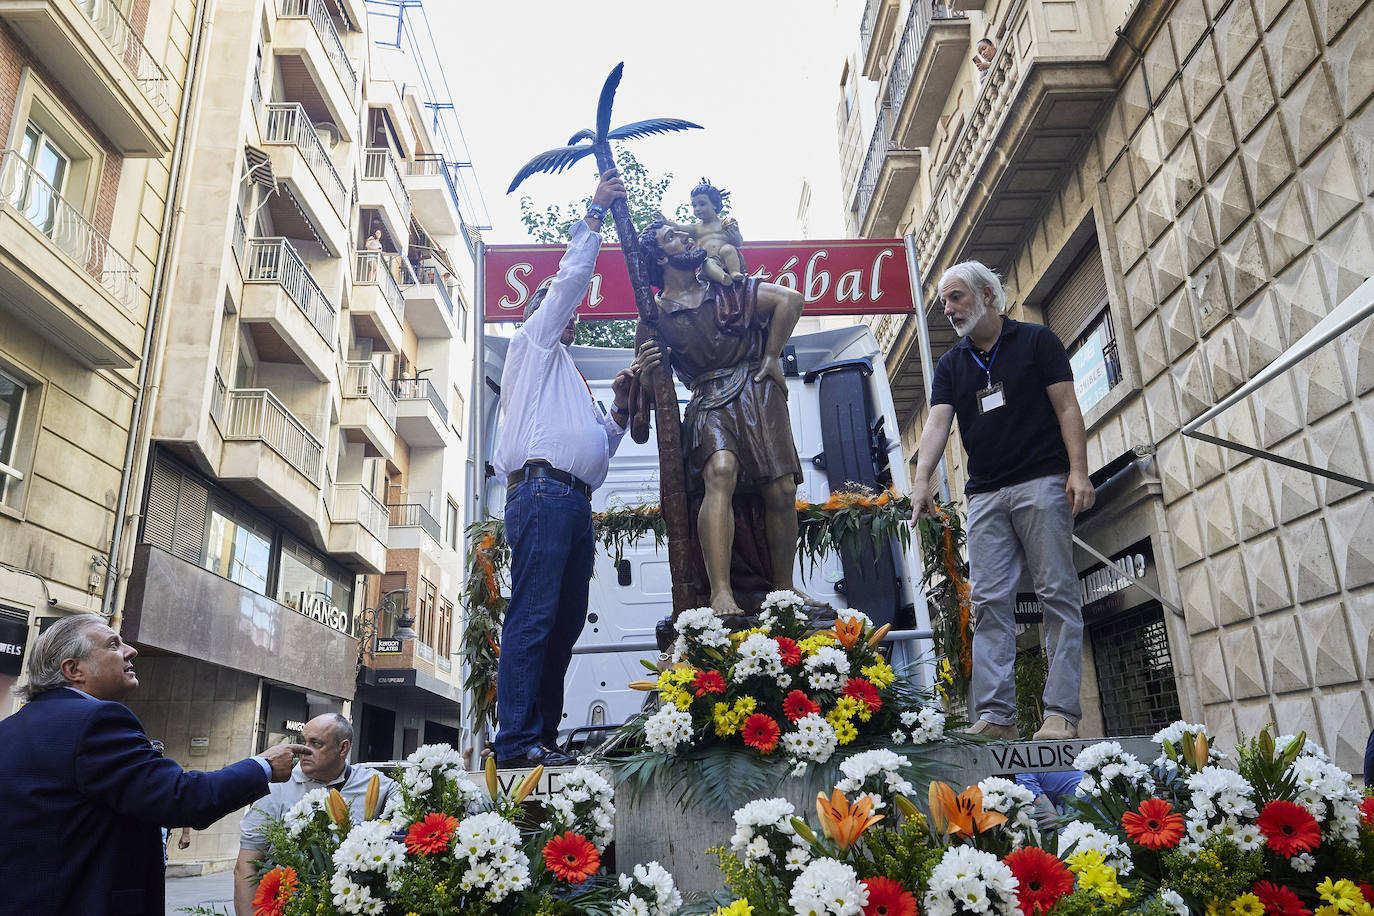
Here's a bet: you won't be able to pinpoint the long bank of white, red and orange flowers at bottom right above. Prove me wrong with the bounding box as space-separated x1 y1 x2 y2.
712 722 1374 916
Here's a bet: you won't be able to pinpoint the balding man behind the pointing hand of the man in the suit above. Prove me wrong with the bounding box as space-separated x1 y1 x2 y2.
234 713 394 916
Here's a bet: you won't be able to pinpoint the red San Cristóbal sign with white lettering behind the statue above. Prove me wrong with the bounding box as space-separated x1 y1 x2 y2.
482 239 915 321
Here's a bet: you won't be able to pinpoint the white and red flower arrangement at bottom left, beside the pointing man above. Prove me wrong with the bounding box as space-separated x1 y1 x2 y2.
253 744 682 916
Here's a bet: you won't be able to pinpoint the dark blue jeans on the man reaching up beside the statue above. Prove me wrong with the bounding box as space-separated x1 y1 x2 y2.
496 478 594 759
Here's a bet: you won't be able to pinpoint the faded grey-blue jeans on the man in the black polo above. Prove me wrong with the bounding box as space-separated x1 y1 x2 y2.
969 474 1083 725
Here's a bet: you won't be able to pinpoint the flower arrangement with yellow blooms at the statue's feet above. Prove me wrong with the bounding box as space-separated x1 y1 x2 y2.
611 592 948 810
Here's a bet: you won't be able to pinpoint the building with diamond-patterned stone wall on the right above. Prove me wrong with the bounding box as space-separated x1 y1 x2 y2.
838 0 1374 769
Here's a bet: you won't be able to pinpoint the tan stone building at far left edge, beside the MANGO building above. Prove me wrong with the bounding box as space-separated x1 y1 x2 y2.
0 0 199 715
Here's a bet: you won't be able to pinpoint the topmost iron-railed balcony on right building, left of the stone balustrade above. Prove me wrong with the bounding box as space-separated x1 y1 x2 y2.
888 3 970 150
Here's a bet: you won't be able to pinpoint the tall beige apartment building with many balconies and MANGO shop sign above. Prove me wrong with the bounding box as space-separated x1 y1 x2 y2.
95 0 473 868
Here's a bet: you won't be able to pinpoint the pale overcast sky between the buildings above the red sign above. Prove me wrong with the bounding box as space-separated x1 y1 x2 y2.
426 0 863 244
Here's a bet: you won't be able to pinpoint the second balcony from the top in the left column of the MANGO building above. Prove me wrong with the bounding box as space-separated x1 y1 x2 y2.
262 102 348 240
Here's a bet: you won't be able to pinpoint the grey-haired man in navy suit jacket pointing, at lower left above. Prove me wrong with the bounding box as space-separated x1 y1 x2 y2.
0 614 306 916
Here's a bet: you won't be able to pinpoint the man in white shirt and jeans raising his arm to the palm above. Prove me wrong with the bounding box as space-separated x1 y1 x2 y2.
495 169 631 766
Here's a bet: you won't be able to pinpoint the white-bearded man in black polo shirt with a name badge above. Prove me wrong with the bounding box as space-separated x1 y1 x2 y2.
912 261 1095 740
